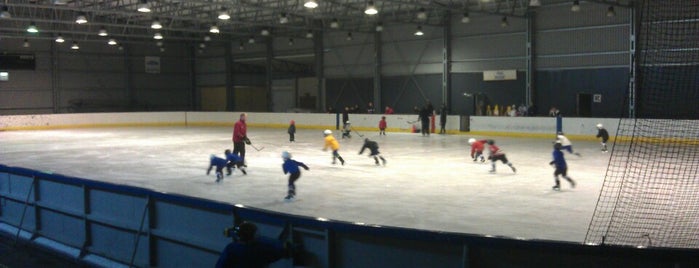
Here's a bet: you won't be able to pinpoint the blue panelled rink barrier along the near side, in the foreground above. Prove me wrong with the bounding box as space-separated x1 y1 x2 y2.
0 165 699 267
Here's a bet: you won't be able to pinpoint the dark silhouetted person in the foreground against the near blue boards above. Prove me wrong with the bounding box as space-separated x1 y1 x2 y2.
216 222 286 268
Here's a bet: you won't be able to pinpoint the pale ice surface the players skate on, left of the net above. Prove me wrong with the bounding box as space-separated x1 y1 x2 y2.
0 127 611 242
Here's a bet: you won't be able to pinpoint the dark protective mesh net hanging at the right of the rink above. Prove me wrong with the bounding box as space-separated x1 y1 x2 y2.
585 0 699 248
